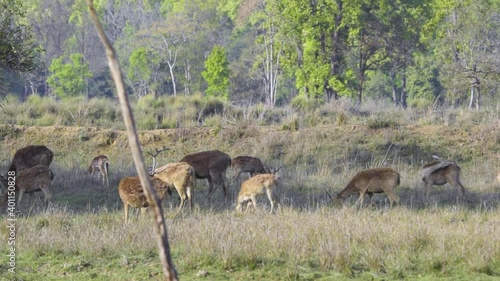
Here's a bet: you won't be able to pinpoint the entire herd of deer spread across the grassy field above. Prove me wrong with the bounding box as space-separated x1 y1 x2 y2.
0 145 490 219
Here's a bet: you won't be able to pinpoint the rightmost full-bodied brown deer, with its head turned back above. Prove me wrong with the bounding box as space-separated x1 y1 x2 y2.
420 154 465 204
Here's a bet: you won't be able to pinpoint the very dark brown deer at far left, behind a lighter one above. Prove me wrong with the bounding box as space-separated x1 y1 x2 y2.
9 145 54 173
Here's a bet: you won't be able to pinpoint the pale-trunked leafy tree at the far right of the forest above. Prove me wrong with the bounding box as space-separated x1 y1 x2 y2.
439 0 500 109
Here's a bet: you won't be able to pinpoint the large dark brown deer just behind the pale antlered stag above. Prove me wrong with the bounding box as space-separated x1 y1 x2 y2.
179 150 231 198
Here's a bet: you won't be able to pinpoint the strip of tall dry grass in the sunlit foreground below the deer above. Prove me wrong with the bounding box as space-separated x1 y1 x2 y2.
1 203 500 280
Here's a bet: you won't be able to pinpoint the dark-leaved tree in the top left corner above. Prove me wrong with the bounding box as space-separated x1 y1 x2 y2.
0 0 40 93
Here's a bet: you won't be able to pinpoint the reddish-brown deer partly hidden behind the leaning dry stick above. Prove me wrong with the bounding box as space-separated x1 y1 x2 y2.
118 177 169 221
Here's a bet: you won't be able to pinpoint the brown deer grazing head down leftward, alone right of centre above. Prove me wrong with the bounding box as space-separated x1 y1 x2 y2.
333 168 400 207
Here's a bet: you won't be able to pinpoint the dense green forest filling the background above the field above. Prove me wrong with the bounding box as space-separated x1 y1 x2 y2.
0 0 500 109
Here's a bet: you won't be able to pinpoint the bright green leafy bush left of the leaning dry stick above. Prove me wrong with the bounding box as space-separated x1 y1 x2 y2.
47 53 92 98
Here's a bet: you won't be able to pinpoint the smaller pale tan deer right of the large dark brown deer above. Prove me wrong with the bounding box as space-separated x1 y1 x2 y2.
236 167 281 213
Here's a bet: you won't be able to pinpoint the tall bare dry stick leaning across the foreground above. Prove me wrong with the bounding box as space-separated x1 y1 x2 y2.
86 0 178 280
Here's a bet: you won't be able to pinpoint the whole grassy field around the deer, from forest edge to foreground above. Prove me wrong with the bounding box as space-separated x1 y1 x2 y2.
0 104 500 280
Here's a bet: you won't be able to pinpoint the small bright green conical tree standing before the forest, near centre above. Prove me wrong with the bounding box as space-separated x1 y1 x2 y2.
201 45 229 100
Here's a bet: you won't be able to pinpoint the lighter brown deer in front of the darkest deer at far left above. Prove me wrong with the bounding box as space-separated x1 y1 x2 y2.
0 165 54 205
